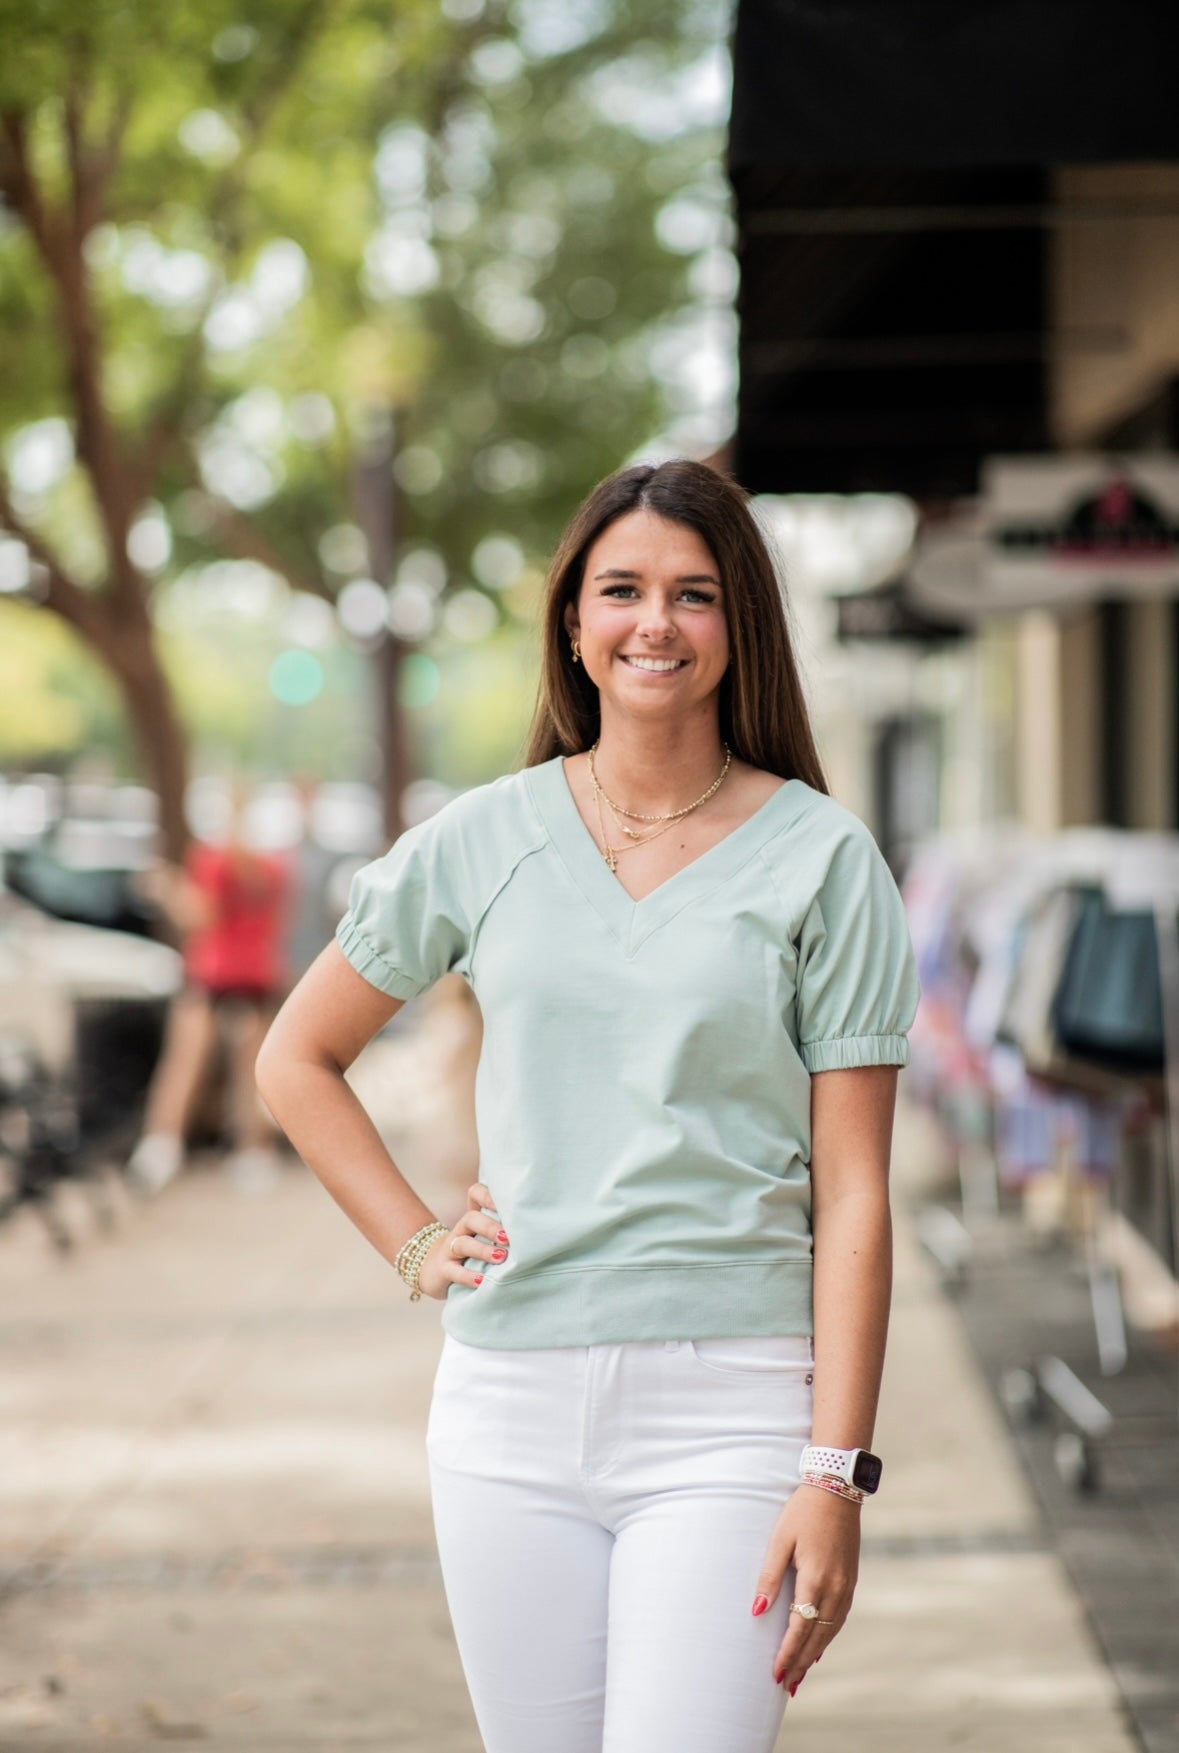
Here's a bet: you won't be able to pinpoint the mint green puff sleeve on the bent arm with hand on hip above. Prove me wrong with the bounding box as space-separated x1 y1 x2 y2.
336 808 471 999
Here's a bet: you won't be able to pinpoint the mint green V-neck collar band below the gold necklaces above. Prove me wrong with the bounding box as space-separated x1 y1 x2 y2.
524 756 808 954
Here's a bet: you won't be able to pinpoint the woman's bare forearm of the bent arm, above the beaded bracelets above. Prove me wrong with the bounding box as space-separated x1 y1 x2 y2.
258 1062 434 1264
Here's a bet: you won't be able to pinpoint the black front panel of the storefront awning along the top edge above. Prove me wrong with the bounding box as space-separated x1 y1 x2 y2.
731 0 1179 170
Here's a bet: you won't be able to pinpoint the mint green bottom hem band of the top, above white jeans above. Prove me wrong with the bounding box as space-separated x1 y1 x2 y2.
441 1260 815 1352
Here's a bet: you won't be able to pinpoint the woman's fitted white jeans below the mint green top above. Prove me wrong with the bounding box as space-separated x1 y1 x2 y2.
426 1334 815 1753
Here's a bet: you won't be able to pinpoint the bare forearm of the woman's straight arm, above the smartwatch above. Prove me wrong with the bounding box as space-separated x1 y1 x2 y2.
811 1189 892 1448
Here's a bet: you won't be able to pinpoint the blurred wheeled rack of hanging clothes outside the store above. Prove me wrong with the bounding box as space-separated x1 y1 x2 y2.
904 829 1179 1490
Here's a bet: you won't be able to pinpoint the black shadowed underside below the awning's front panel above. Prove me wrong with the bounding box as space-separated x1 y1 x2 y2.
734 170 1049 498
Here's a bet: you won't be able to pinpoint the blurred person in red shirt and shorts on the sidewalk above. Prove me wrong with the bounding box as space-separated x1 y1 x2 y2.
128 787 291 1192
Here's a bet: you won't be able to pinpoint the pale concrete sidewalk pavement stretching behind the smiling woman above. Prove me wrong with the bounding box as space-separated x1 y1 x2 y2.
0 1041 1137 1753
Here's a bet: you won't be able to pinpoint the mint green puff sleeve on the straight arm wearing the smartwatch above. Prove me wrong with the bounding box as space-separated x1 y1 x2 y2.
795 824 920 1071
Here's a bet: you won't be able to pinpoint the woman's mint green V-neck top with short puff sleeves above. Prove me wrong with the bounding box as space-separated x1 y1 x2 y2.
336 757 918 1350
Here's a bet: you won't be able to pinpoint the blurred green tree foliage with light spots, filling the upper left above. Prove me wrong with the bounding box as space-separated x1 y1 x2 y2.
0 0 725 854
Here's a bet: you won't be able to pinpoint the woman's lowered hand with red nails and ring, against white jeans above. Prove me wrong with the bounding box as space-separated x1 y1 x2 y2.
755 1485 860 1697
